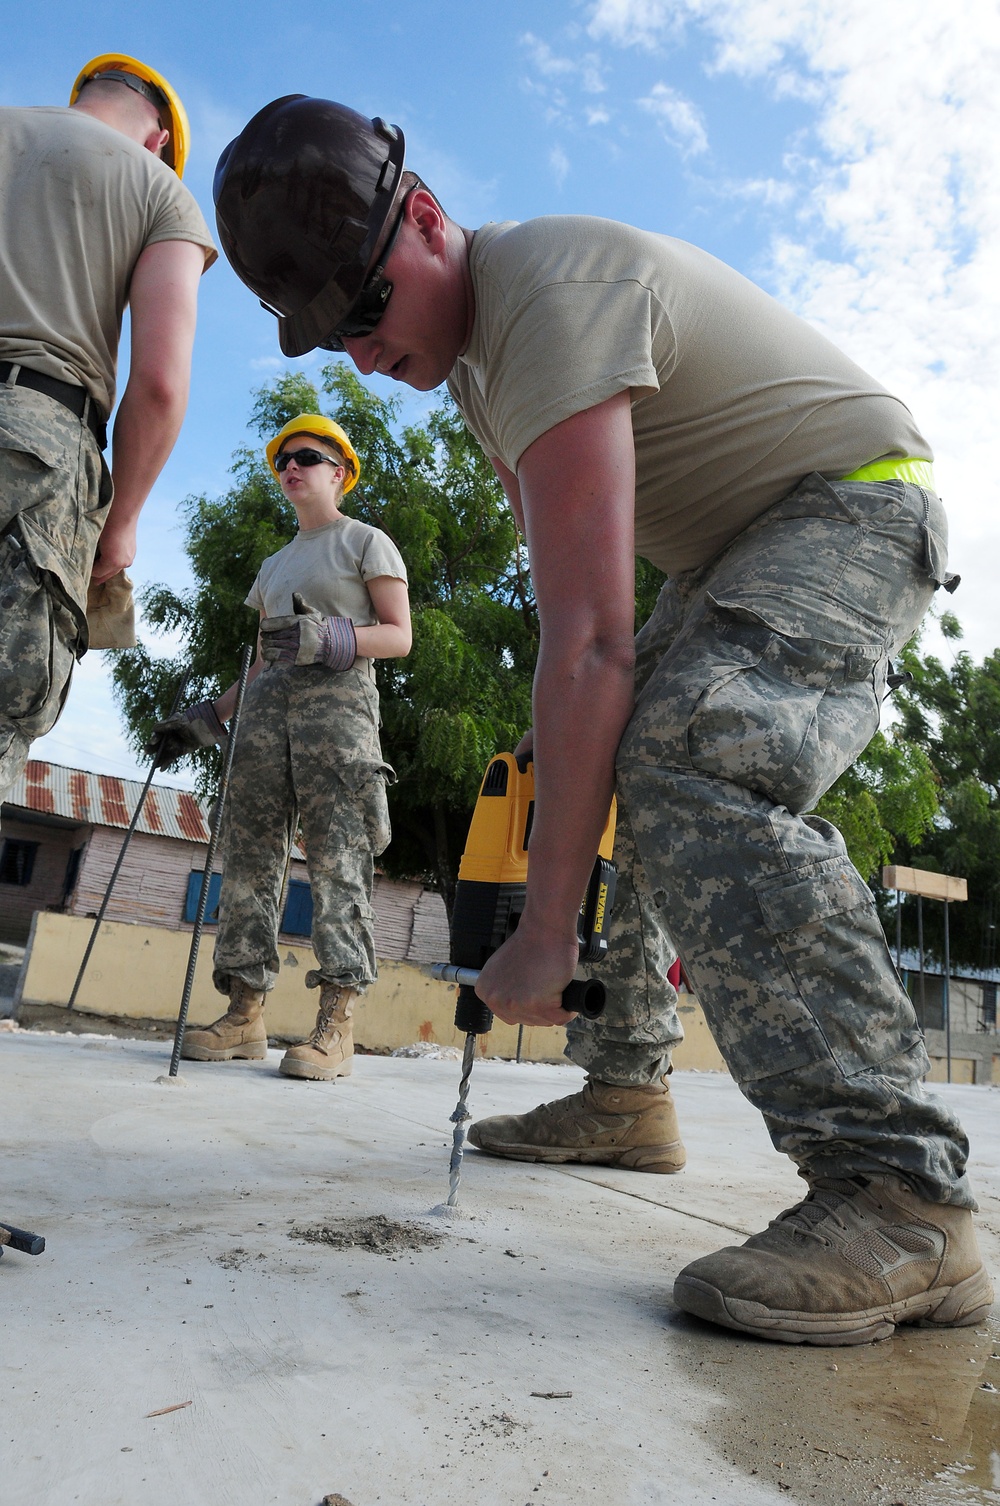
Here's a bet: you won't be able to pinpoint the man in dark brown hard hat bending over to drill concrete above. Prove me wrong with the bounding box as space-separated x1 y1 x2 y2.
215 95 992 1343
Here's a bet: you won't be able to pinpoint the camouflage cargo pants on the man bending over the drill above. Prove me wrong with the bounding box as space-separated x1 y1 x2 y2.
566 476 974 1206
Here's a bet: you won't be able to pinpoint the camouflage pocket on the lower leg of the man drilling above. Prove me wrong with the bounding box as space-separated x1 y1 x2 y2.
753 855 919 1077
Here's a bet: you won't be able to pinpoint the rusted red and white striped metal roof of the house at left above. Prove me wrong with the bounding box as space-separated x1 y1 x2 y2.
5 759 209 842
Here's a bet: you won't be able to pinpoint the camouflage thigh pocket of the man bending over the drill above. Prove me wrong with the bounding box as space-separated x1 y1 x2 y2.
687 596 889 813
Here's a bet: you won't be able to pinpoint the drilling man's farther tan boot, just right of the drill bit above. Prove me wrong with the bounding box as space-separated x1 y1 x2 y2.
468 1077 687 1173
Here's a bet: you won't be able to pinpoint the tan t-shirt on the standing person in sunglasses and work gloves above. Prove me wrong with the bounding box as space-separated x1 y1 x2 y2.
247 518 407 656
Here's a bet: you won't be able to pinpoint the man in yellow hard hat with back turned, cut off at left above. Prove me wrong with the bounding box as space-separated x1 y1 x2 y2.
0 53 217 798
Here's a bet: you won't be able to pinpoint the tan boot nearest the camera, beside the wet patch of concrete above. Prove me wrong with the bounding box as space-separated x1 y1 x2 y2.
673 1176 992 1345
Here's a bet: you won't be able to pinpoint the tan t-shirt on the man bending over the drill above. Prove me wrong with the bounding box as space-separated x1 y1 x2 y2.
449 215 932 575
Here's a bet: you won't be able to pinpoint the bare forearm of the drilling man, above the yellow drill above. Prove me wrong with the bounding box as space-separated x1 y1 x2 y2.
521 643 634 940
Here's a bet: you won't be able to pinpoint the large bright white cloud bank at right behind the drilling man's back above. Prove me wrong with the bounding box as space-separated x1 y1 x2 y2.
589 0 1000 654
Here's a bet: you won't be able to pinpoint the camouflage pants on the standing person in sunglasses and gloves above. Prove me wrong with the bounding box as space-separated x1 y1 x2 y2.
214 661 395 992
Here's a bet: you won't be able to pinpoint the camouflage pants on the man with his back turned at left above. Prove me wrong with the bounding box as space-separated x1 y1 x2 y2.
0 384 111 800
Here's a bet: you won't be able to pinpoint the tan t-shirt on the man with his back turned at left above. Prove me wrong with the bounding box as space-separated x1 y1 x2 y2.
0 107 218 417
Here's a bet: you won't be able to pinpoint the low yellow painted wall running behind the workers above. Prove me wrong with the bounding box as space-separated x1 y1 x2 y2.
21 911 726 1072
